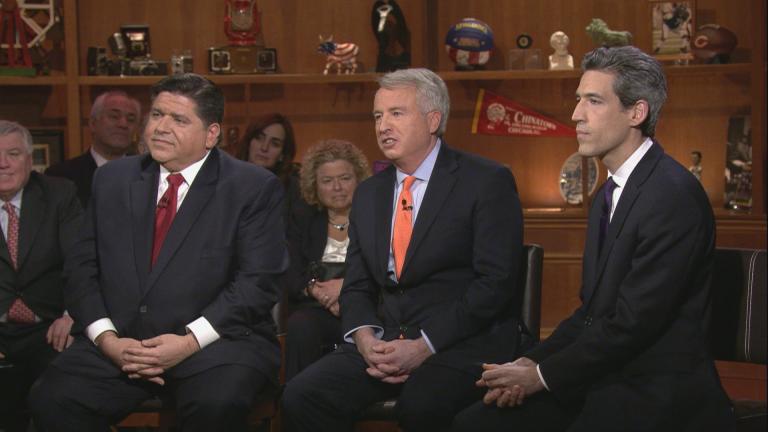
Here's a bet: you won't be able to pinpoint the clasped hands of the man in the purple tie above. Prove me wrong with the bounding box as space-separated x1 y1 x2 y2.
475 357 544 408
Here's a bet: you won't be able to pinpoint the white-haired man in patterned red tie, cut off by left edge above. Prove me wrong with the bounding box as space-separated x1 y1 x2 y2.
0 120 82 431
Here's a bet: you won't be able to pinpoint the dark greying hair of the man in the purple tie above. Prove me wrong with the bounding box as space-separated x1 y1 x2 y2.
581 46 667 137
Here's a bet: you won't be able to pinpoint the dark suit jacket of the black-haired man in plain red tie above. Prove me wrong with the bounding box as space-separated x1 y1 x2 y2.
54 148 287 377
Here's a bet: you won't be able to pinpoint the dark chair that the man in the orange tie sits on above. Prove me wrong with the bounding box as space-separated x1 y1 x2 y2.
356 244 544 431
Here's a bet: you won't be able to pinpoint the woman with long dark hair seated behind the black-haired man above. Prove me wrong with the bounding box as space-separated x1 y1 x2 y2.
237 113 307 223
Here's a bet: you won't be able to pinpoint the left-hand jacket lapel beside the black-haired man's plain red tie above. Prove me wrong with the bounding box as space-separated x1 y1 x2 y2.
130 156 160 288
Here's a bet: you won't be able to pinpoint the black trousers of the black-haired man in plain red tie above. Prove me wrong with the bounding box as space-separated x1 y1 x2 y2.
30 365 271 432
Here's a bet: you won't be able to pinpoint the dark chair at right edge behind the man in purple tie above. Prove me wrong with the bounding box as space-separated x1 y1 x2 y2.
710 249 768 431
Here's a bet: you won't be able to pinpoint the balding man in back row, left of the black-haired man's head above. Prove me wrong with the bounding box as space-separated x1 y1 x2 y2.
45 90 141 207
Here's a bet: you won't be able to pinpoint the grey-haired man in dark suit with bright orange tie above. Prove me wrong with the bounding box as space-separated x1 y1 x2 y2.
283 69 522 431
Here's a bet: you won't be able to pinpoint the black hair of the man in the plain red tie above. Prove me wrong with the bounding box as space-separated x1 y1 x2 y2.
151 73 224 127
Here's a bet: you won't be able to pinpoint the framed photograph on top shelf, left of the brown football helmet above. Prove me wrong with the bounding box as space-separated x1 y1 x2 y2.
650 0 696 62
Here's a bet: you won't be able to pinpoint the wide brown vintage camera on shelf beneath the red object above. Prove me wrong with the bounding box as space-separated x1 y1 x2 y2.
208 45 277 74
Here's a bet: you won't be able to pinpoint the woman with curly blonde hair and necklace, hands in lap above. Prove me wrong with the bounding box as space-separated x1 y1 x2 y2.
284 140 370 380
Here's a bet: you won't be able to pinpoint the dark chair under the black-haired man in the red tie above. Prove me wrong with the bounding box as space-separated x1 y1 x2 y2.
117 303 285 432
